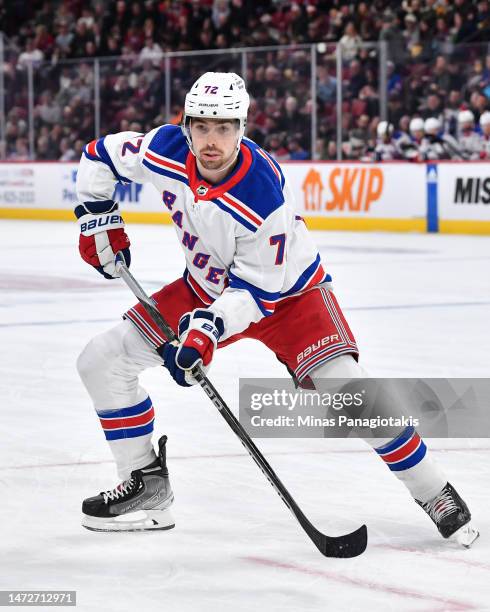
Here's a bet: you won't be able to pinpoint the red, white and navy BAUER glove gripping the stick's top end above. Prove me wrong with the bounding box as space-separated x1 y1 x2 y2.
75 200 131 278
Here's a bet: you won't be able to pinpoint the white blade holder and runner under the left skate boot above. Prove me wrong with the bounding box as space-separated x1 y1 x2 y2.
82 510 175 531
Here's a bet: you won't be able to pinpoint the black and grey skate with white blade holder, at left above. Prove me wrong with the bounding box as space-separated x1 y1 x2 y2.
82 436 175 531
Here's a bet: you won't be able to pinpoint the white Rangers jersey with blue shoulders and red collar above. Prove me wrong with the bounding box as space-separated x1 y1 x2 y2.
77 125 331 340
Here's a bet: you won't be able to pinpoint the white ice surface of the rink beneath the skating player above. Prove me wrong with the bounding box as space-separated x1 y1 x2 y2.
0 221 490 612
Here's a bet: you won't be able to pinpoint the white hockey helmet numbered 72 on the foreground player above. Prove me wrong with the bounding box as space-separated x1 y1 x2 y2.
182 72 250 153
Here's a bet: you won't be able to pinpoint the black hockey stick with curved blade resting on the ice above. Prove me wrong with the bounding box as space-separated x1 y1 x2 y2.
116 253 367 558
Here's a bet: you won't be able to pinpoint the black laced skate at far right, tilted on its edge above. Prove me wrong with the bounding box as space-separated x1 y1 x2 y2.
415 482 480 548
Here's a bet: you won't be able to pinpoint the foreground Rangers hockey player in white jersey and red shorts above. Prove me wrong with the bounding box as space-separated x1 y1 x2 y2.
75 72 477 545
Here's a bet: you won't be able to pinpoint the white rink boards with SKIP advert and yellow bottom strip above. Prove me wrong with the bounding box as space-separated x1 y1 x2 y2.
0 161 490 234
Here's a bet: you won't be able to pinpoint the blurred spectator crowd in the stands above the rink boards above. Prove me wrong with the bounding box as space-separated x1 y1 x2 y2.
0 0 490 161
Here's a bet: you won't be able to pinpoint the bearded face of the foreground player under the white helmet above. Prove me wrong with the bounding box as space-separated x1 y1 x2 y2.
191 119 238 170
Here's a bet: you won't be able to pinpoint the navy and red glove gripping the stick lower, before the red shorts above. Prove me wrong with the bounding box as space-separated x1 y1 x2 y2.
158 309 225 387
